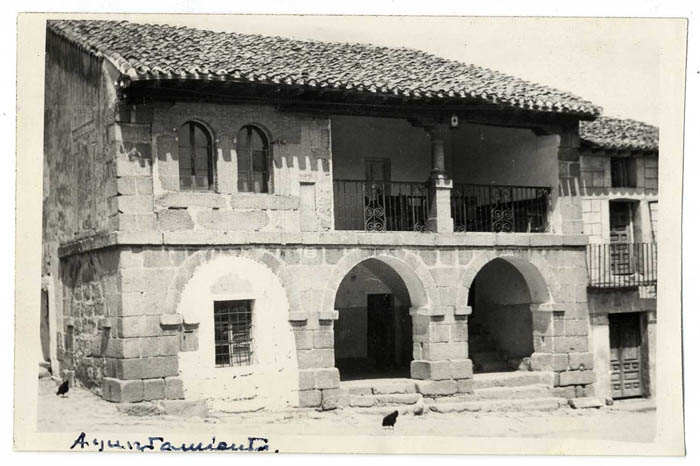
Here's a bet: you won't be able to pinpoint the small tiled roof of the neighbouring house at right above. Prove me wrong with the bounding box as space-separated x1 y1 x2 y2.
579 117 659 151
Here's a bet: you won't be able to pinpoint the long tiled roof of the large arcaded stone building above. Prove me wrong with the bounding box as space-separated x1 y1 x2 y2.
48 20 600 117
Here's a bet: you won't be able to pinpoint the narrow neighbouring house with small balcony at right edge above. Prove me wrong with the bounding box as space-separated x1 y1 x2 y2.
580 117 659 398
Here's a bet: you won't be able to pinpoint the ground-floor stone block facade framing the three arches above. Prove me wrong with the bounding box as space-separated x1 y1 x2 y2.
58 237 593 406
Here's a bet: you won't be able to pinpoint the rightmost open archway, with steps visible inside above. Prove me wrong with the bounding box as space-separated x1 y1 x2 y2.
468 257 548 373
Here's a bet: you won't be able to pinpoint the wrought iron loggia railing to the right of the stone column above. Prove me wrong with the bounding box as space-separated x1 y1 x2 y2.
451 184 552 233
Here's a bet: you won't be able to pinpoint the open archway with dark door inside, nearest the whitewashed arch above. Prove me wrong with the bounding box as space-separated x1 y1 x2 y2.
334 258 413 380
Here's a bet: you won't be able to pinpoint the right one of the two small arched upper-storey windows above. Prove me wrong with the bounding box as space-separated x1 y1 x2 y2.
236 125 270 193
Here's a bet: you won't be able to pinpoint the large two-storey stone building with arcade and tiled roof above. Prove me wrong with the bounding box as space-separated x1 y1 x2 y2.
42 20 624 409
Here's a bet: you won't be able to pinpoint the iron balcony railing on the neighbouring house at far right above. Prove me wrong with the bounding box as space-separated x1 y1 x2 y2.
586 243 657 288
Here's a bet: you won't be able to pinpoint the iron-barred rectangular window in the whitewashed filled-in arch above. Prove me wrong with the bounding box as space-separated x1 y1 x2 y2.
214 300 253 367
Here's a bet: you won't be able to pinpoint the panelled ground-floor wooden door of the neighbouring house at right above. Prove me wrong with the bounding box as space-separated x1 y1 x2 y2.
608 313 643 398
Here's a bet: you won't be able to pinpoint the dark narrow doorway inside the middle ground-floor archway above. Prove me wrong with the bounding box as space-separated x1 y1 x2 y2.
367 294 396 370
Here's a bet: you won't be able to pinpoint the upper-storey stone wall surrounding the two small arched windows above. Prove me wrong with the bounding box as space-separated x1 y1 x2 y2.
110 103 333 242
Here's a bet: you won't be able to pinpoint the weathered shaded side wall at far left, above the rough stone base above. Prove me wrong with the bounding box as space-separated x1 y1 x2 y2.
42 31 123 378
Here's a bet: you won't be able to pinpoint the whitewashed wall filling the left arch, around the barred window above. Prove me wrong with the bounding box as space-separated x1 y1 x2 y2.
176 255 298 409
